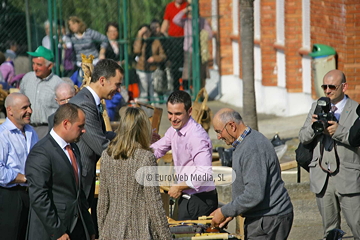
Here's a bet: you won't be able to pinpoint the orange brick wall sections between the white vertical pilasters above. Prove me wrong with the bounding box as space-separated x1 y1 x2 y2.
199 0 360 101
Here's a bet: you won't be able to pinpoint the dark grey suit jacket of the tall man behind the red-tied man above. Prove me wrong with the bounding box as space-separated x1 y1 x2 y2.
70 88 113 198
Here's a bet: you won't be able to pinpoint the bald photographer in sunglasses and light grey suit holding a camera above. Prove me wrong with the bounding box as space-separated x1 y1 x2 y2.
299 70 360 239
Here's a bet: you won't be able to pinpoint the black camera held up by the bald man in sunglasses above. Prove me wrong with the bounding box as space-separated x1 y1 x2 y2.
311 97 337 134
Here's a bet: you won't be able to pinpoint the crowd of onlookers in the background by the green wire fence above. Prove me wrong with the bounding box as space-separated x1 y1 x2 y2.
0 0 212 104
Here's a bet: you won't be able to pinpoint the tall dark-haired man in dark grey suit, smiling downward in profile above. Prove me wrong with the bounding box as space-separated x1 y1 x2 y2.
70 59 124 202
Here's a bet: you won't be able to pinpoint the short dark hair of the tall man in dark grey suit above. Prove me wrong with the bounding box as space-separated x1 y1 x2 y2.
91 59 124 82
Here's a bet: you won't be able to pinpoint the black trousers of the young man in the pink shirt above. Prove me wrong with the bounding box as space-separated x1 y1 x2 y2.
178 189 218 220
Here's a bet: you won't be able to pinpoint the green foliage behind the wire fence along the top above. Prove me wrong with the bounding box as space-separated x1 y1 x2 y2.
11 0 171 37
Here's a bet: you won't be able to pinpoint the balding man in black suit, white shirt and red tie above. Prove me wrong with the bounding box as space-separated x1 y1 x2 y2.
25 103 95 240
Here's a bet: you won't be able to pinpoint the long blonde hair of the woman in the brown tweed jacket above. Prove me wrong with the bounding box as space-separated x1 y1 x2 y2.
107 107 151 159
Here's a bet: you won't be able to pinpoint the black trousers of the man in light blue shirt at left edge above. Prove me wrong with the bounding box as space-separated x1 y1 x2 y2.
0 186 30 240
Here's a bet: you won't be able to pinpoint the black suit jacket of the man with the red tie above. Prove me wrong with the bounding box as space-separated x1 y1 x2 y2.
25 134 95 240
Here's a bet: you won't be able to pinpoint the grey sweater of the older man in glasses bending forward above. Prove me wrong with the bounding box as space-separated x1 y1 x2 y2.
221 129 293 217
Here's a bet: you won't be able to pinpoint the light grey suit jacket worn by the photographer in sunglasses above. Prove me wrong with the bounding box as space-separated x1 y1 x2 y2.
299 98 360 194
